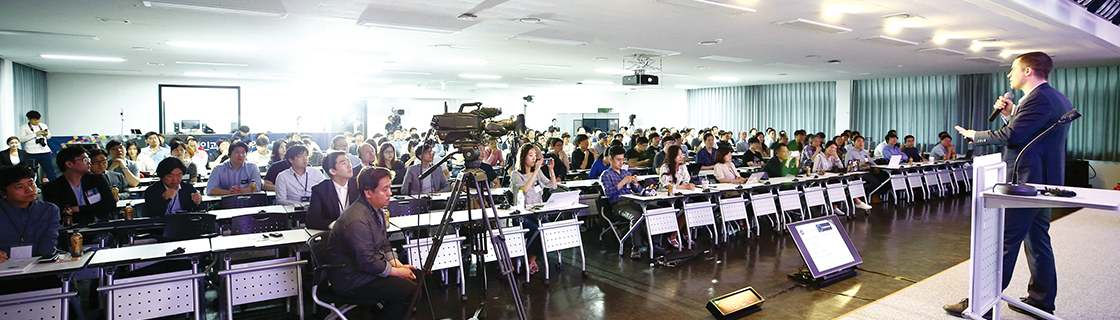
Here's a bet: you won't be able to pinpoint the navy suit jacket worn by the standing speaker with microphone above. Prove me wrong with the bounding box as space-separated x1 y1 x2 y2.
972 83 1073 186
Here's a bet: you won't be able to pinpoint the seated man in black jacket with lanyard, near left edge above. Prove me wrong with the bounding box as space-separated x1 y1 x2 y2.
43 145 116 224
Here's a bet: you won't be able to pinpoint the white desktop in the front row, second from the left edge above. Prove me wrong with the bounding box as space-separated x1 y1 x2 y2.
90 238 211 266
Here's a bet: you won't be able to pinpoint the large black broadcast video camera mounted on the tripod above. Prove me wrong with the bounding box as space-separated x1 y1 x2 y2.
431 102 525 162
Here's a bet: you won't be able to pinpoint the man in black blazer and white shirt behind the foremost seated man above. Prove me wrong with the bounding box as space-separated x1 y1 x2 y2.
307 151 358 230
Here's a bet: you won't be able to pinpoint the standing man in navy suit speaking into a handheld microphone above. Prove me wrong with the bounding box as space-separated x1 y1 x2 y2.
945 51 1073 316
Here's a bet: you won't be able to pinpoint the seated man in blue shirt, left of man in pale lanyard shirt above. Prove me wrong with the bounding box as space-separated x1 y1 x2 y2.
206 141 263 196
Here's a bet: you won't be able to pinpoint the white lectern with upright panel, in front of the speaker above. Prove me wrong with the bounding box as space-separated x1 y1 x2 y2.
964 153 1120 320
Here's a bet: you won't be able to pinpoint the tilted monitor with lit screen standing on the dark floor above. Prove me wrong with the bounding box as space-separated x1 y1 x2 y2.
788 215 864 288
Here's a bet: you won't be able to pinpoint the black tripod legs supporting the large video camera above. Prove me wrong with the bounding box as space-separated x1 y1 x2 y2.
409 145 525 320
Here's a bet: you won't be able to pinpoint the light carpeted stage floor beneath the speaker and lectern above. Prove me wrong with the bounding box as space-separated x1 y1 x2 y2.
840 209 1120 319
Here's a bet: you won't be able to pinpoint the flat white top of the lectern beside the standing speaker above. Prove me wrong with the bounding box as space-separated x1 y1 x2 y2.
982 185 1120 210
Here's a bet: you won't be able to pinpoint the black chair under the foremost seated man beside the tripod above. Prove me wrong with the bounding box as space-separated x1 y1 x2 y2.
307 230 382 320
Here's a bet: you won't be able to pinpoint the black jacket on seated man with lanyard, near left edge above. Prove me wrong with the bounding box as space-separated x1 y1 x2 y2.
43 173 116 224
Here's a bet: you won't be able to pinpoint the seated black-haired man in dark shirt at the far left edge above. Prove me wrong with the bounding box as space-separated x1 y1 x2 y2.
0 166 62 259
